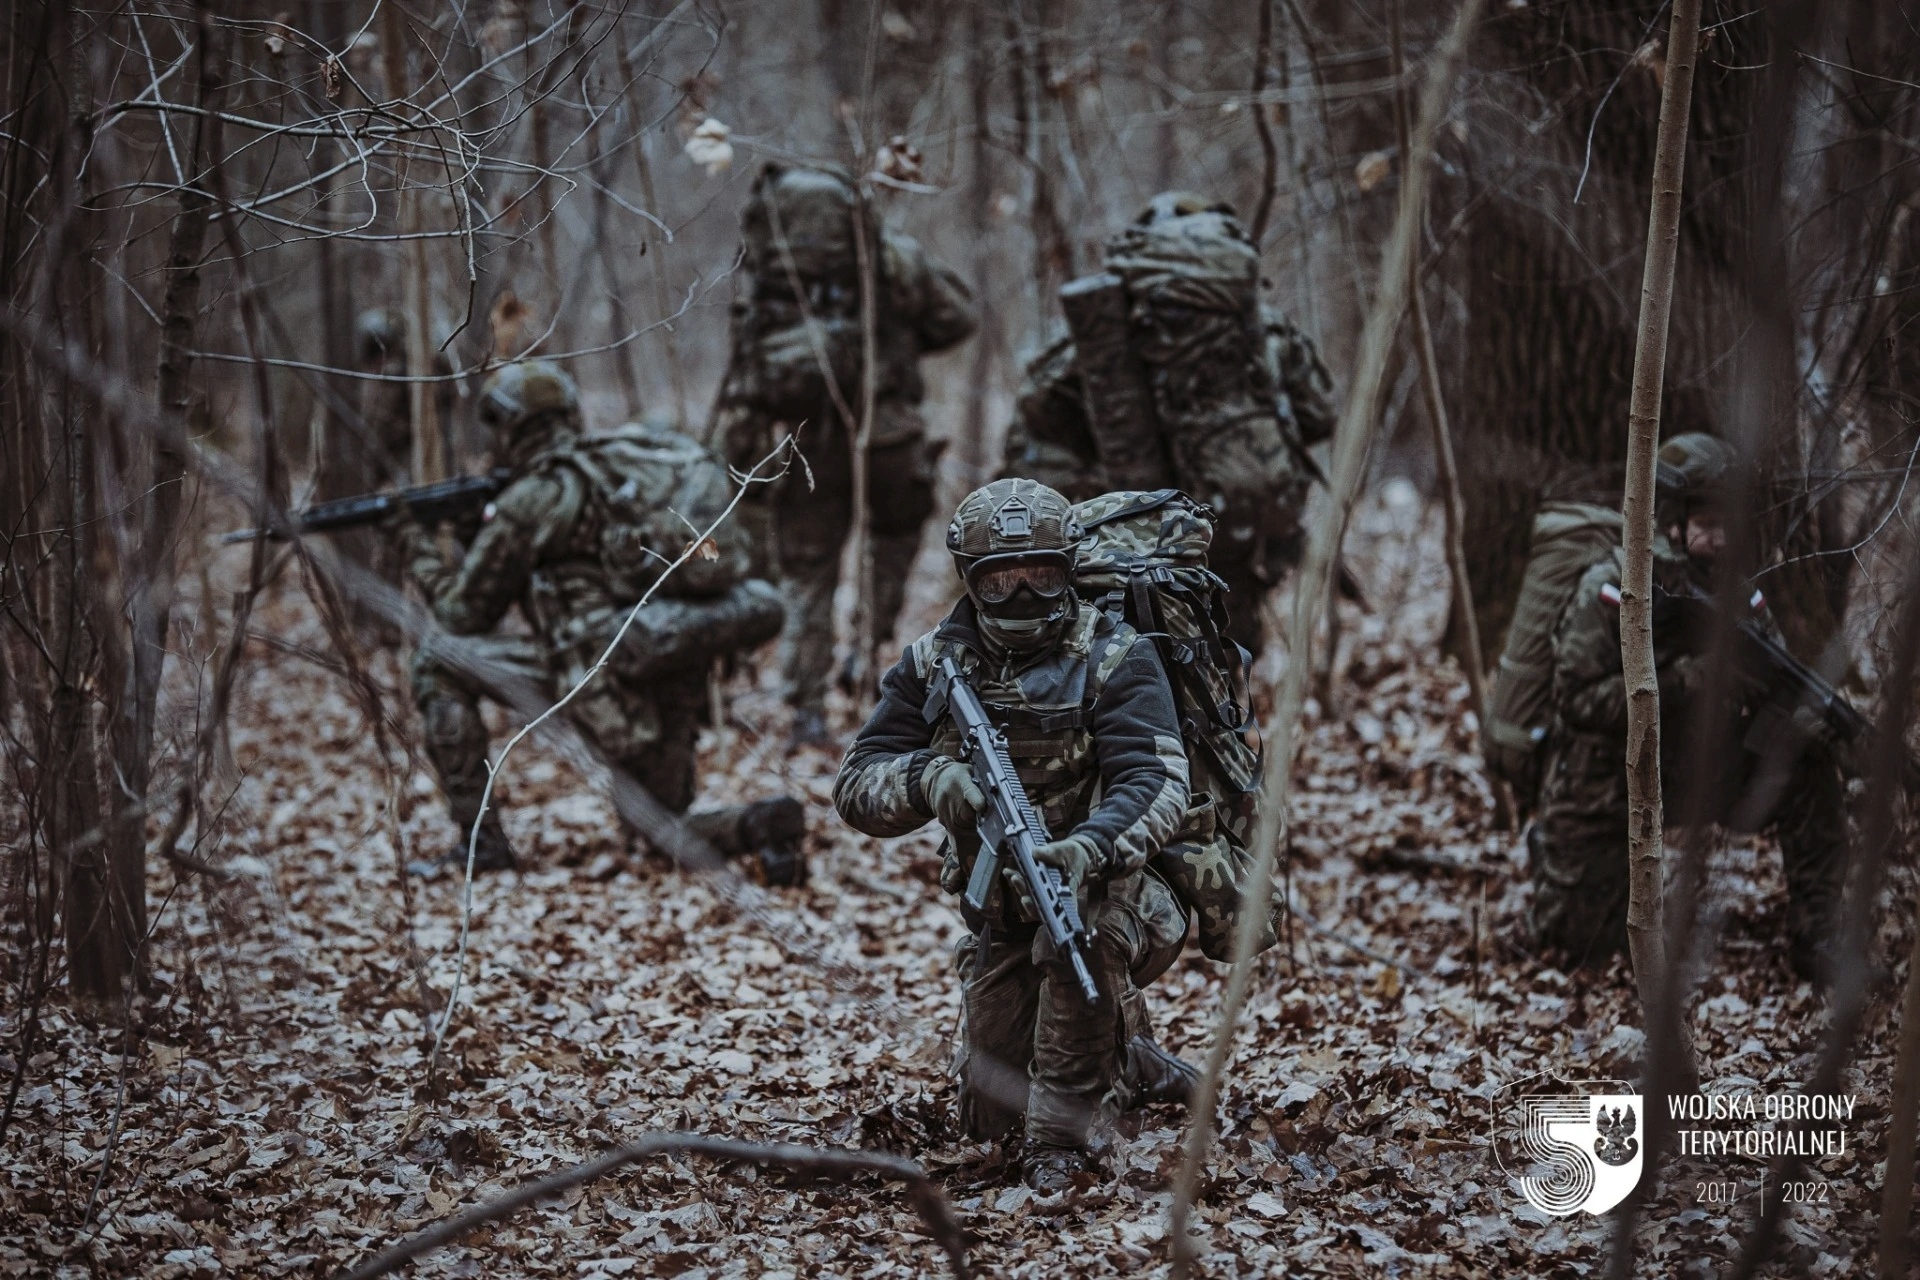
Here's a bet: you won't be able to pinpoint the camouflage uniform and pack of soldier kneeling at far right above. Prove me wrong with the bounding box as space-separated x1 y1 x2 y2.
1528 541 1847 965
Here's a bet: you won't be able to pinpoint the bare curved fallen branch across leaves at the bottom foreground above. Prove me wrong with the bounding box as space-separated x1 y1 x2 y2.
336 1134 968 1280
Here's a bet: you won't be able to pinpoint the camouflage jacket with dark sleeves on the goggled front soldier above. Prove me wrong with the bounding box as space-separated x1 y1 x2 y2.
833 599 1188 890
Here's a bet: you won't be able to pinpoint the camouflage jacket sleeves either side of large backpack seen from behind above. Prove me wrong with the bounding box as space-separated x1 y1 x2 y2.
1000 307 1338 503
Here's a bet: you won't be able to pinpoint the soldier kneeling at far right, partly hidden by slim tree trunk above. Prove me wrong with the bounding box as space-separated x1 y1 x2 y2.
1526 432 1847 977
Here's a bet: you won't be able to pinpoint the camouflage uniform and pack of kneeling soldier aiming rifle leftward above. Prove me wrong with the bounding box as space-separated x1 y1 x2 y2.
409 424 780 848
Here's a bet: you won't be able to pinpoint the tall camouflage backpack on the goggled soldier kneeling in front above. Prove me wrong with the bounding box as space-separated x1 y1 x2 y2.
1073 489 1275 960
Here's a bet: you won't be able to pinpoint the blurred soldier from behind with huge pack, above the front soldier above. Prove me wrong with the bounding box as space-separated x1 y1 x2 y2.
1002 192 1334 652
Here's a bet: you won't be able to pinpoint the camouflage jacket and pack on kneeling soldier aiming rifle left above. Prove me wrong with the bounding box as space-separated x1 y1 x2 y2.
411 424 747 651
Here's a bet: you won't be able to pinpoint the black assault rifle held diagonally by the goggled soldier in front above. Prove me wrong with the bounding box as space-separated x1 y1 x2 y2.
925 656 1100 1004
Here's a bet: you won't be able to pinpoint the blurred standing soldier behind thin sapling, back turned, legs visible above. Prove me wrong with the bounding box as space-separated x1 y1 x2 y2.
712 165 977 741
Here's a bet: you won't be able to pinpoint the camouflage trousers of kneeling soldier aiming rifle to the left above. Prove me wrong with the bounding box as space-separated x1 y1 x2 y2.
411 635 741 854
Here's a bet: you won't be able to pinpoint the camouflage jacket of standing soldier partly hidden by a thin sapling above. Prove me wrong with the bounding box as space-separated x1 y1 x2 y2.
712 230 979 468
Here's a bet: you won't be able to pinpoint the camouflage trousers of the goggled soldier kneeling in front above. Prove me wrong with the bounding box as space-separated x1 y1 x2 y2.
956 871 1187 1148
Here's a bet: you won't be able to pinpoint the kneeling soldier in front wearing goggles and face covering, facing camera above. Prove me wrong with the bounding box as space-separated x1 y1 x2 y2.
833 480 1192 1192
